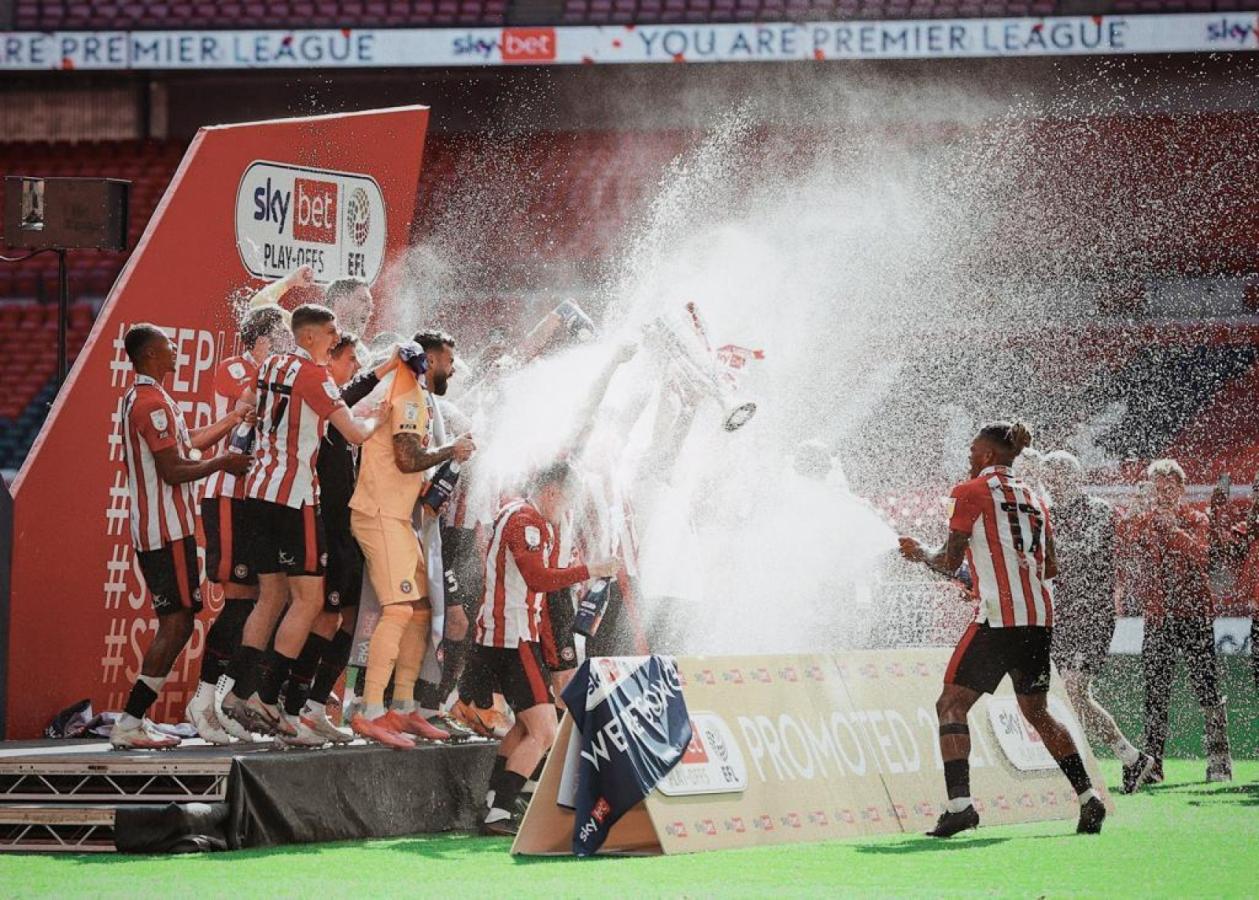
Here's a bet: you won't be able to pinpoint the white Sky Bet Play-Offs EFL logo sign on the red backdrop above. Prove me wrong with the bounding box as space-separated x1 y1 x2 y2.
235 161 385 284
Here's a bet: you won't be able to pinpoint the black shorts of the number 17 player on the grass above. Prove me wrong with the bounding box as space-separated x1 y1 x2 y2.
944 622 1053 694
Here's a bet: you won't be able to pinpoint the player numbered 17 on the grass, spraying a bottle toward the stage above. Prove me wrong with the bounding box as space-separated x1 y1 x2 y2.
900 422 1105 837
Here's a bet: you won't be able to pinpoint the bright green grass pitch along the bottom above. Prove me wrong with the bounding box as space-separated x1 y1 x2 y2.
0 760 1259 900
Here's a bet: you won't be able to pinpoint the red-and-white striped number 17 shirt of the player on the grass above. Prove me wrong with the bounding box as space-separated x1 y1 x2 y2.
948 466 1054 628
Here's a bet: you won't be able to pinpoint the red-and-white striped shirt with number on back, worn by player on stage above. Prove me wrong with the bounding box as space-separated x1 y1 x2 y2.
244 347 345 510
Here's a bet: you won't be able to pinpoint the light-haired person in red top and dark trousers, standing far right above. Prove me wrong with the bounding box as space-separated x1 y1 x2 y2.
1132 459 1233 782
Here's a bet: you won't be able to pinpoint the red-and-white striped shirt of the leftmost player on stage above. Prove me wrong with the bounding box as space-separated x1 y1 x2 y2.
122 375 196 550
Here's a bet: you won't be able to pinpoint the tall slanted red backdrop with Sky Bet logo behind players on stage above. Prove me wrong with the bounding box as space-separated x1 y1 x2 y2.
8 107 428 738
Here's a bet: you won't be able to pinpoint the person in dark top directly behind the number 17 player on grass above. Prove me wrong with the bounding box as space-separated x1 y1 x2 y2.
1025 451 1155 793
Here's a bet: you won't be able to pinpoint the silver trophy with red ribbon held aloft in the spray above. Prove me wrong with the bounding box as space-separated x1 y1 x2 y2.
643 303 757 432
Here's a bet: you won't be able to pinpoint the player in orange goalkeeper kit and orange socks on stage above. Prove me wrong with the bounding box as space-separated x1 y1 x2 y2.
350 336 476 749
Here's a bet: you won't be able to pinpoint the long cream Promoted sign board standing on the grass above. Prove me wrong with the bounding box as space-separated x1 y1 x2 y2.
512 648 1109 853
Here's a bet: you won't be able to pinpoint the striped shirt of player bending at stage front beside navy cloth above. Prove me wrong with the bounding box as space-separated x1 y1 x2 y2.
476 500 590 650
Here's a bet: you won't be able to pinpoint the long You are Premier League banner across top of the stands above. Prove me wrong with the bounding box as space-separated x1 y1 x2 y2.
0 13 1259 70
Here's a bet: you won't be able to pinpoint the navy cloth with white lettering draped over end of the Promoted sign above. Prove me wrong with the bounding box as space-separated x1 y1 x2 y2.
562 656 691 856
